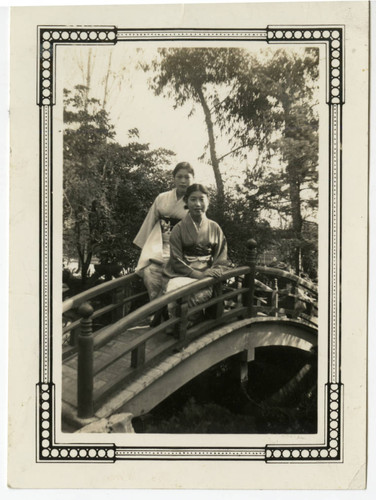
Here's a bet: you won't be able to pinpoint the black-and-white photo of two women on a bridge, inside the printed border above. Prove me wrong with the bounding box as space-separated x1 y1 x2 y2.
61 42 320 434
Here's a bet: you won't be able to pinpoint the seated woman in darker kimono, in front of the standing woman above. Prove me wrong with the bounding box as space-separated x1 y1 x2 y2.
164 184 228 316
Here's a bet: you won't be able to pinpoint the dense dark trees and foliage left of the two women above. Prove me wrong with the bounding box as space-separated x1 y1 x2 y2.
63 86 173 283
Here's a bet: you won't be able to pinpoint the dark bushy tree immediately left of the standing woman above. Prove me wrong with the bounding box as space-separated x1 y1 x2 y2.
93 142 174 269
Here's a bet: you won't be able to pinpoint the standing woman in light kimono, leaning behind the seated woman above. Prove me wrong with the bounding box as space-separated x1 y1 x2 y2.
133 162 194 300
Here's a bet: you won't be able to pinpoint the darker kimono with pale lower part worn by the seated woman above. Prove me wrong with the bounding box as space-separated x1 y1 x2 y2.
164 214 228 316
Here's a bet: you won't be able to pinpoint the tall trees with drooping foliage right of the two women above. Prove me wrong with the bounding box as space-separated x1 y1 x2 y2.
148 48 318 272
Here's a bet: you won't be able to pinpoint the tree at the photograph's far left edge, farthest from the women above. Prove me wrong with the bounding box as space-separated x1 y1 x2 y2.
63 85 114 283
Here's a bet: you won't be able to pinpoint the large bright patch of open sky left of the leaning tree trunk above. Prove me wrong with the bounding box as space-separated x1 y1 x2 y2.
58 44 222 183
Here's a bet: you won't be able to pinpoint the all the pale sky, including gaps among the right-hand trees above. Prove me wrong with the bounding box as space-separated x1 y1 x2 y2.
57 42 313 227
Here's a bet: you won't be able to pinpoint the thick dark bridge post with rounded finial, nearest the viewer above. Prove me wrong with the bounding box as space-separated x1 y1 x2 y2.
77 302 94 418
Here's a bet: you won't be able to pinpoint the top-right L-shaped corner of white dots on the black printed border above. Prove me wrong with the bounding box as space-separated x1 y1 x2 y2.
267 26 345 104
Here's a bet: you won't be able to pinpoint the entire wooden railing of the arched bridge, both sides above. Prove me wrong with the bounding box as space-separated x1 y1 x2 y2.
63 242 317 418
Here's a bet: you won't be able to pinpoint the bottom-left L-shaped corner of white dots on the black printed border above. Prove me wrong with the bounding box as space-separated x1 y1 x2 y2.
37 383 116 463
